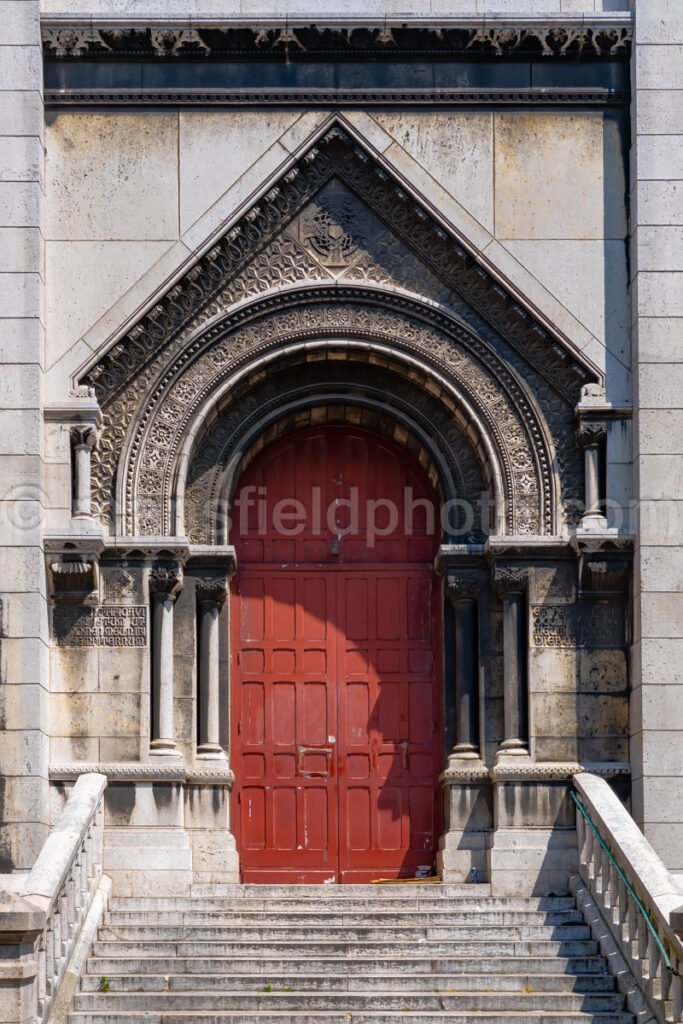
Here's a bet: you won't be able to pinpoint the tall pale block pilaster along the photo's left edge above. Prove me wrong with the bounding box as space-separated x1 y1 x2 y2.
0 0 49 868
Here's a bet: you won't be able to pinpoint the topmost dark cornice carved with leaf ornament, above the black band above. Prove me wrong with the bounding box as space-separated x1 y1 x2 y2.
42 18 633 60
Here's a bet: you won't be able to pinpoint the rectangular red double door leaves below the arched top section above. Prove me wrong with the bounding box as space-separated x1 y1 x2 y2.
232 566 441 882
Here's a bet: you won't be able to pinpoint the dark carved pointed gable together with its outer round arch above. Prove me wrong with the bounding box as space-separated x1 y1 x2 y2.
84 127 591 536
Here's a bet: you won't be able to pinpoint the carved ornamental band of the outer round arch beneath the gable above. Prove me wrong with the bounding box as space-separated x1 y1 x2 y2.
126 289 551 536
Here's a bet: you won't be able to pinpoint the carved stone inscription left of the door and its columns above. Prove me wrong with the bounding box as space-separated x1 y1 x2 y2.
53 605 147 647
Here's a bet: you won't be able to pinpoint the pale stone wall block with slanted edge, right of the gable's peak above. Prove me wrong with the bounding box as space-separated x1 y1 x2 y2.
374 111 494 233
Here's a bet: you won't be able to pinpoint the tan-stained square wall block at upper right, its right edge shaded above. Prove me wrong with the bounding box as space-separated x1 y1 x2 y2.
495 112 627 240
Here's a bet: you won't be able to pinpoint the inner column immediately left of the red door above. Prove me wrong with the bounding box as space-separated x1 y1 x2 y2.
197 575 227 758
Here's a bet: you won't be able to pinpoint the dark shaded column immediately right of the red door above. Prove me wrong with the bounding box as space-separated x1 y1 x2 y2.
445 572 479 760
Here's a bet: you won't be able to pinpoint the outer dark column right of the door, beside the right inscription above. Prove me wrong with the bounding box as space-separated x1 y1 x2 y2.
494 566 528 758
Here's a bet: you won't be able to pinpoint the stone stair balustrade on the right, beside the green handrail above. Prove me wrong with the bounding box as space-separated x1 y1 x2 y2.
574 773 683 1024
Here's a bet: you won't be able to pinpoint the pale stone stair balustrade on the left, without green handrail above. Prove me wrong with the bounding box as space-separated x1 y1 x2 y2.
0 772 106 1024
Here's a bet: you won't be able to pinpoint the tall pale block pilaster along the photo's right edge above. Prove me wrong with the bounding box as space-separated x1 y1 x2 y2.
631 0 683 871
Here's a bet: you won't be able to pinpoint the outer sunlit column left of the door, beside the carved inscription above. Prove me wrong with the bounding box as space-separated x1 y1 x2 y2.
150 565 183 754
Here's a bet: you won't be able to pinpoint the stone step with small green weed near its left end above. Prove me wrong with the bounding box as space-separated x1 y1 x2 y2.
82 962 615 993
